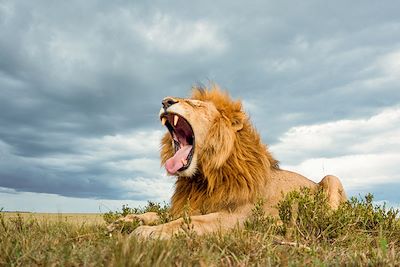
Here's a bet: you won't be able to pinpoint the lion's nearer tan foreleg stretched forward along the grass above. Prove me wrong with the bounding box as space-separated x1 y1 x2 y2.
132 207 251 238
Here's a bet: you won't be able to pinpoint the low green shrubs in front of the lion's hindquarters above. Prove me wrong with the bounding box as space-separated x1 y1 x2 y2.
278 188 400 241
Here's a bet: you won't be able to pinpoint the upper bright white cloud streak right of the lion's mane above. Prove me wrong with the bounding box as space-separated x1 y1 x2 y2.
271 107 400 163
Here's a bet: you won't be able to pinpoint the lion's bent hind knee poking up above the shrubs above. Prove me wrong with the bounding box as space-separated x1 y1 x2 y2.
318 175 347 209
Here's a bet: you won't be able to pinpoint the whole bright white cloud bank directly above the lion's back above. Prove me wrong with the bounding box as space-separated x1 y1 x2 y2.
271 107 400 193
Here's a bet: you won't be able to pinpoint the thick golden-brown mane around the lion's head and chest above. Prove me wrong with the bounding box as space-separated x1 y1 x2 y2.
161 85 279 217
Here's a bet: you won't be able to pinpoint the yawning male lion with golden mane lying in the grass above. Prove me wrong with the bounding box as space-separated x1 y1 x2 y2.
109 85 347 238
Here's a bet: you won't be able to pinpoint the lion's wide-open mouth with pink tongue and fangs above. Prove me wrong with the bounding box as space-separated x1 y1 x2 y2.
160 113 194 174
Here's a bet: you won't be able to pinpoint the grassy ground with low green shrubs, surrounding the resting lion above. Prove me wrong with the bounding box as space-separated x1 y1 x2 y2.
0 190 400 266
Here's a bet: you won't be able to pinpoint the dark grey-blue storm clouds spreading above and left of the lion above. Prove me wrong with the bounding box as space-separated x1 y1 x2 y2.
0 1 400 199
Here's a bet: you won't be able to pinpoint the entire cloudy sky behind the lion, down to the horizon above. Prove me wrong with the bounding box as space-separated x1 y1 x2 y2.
0 0 400 212
